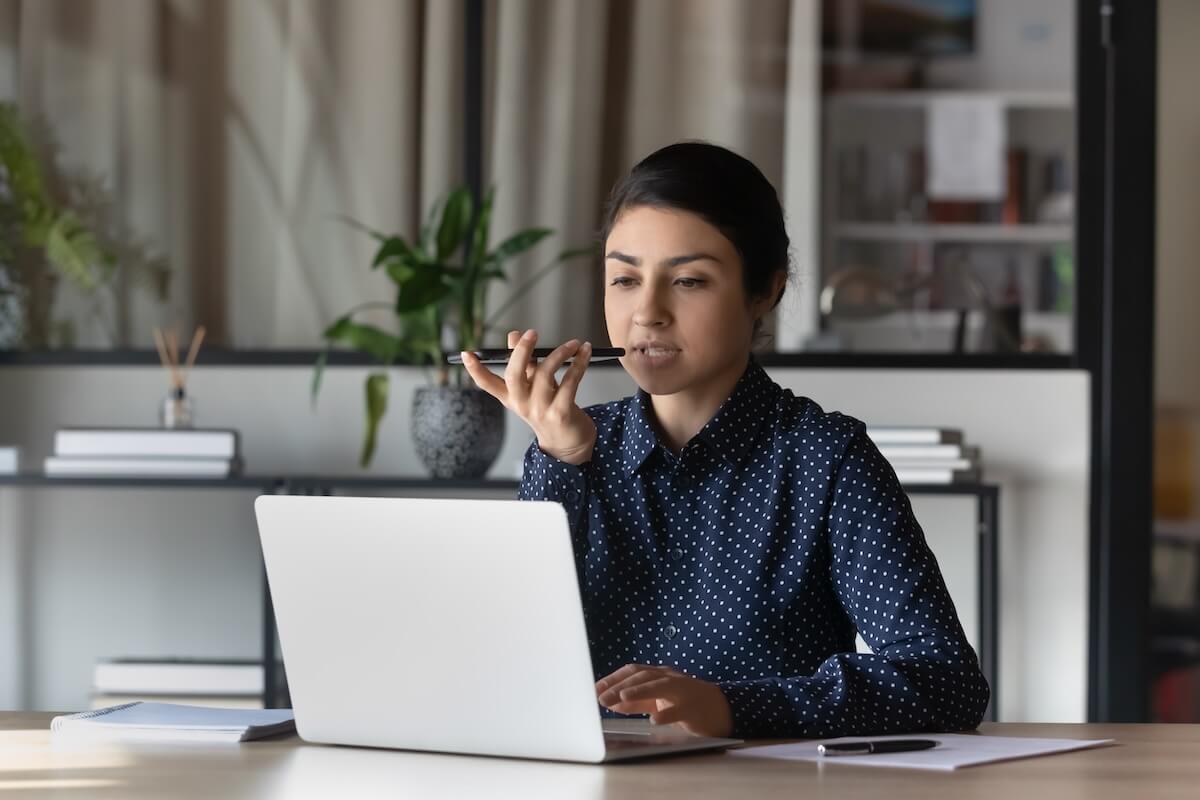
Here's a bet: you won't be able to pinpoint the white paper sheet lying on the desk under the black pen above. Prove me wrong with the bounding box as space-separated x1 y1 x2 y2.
728 733 1116 771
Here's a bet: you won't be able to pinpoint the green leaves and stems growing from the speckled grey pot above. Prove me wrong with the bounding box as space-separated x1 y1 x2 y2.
312 187 593 467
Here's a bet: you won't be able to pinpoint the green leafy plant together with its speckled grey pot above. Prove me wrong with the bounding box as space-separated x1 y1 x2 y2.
312 187 593 477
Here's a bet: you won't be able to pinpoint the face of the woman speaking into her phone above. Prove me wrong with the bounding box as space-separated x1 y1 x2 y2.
604 206 761 395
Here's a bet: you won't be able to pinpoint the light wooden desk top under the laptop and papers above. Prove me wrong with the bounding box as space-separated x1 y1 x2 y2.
0 712 1200 800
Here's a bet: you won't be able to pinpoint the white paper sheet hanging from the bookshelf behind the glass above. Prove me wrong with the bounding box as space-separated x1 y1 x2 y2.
925 96 1008 200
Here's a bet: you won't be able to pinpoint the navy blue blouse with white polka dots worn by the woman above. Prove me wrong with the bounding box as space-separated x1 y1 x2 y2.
520 360 989 738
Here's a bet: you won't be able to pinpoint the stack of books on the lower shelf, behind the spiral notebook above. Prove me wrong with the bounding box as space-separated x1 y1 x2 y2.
91 658 263 709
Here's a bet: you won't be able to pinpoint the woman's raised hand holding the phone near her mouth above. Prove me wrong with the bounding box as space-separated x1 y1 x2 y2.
462 330 596 464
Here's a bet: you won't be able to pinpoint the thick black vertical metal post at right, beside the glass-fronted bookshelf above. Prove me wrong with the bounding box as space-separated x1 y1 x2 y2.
1076 0 1158 722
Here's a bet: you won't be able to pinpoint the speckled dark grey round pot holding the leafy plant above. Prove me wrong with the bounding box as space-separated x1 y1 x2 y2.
413 386 504 479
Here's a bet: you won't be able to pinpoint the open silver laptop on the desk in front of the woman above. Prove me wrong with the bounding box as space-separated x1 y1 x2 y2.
254 495 738 763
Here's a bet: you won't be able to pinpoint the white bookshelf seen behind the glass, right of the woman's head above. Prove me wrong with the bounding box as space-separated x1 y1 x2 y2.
821 90 1075 353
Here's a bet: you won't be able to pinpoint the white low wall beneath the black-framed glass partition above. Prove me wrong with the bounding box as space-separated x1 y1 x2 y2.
0 367 1090 721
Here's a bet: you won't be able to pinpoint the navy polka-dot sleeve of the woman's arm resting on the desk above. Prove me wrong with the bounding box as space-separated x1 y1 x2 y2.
720 423 990 738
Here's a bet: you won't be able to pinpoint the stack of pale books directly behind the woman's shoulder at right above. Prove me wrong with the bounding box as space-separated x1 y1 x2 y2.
866 426 980 483
